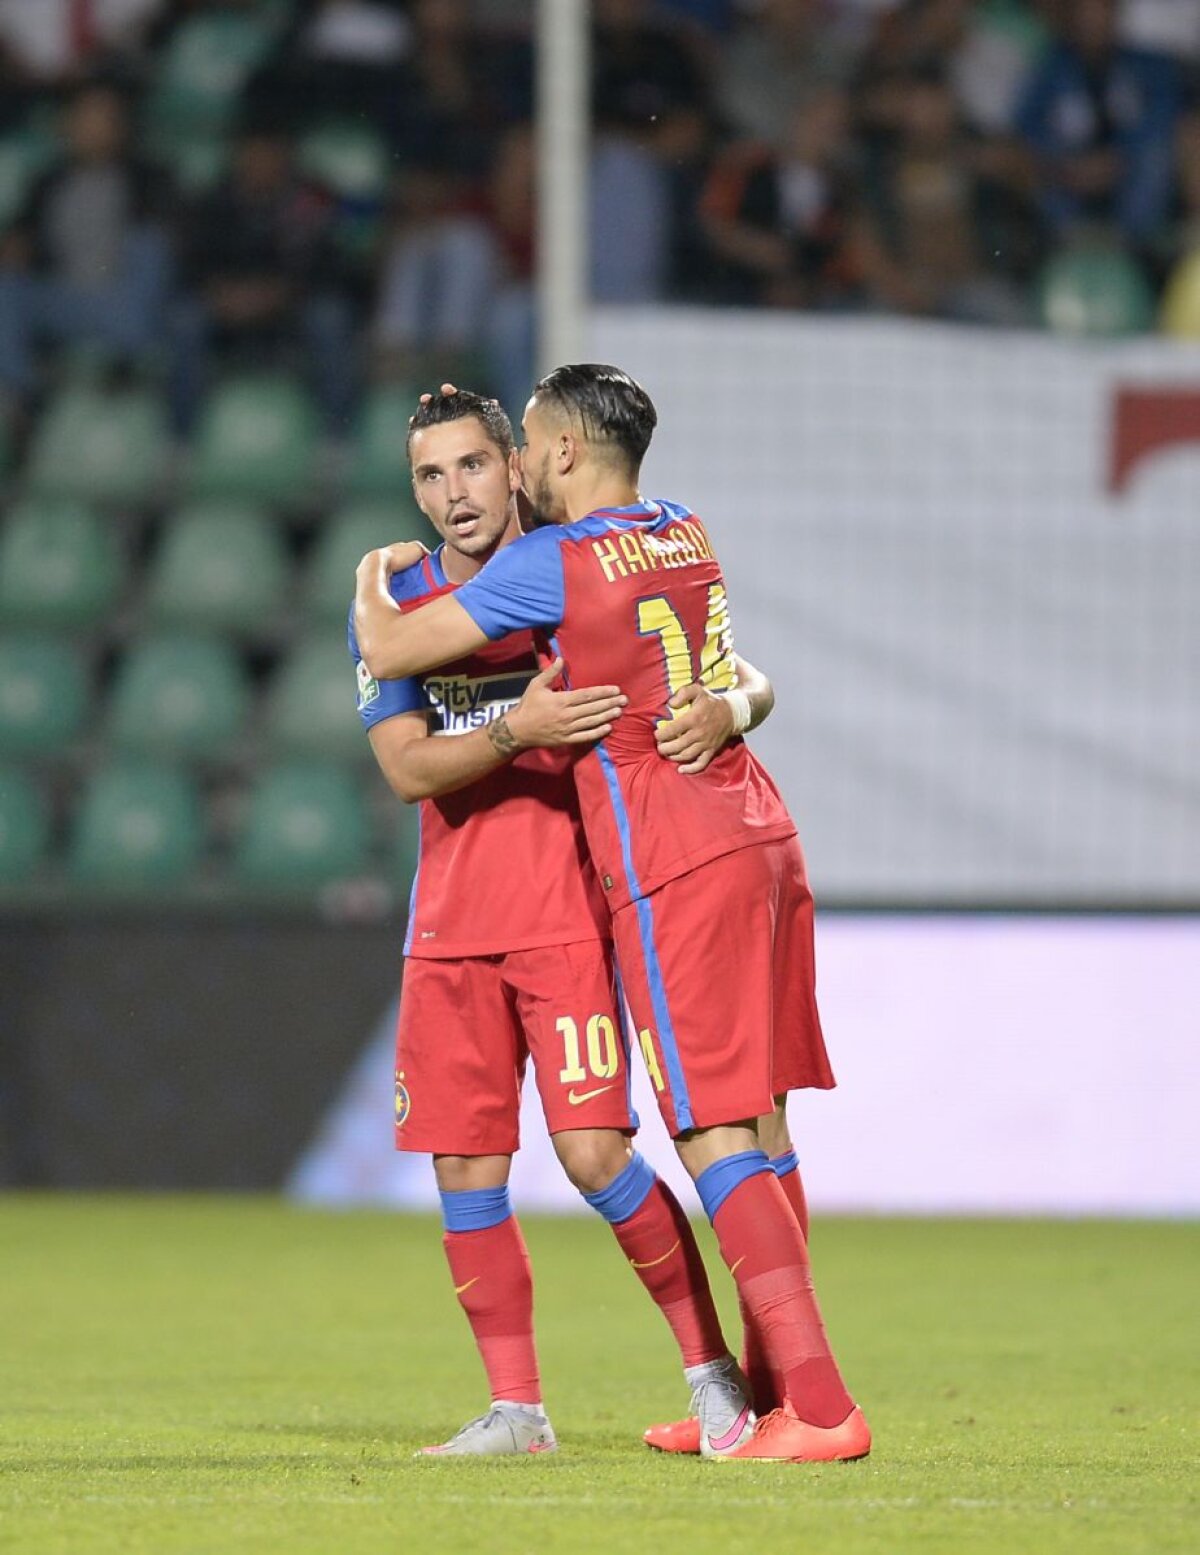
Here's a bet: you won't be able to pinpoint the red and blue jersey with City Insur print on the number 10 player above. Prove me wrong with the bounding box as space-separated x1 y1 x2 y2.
350 550 609 959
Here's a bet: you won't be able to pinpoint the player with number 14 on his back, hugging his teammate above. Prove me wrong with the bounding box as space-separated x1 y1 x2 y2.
354 365 870 1462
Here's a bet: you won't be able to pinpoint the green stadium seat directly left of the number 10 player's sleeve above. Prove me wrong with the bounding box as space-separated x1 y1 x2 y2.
267 631 370 760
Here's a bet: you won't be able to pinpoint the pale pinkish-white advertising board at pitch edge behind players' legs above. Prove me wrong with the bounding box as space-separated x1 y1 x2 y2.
289 914 1200 1214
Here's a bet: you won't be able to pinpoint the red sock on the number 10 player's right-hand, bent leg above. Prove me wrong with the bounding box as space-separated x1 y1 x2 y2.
612 1179 729 1365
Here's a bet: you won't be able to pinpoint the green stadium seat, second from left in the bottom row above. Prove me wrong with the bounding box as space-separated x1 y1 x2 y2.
68 762 204 888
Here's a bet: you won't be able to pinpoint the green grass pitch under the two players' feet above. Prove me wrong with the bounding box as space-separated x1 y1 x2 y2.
0 1196 1200 1555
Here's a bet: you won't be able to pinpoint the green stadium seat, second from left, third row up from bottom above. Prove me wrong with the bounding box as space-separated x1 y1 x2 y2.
146 501 289 633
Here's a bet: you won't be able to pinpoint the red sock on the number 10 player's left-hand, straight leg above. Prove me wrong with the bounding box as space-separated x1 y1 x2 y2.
441 1214 541 1404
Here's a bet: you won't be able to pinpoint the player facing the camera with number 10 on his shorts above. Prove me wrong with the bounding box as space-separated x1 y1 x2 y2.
350 393 769 1454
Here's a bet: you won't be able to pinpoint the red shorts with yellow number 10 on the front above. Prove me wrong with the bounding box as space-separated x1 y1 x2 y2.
396 939 637 1155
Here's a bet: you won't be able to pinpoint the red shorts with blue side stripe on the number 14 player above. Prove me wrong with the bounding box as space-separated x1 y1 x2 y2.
612 837 835 1135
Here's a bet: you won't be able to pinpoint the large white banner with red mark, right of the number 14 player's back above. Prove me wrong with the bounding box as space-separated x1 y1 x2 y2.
592 309 1200 907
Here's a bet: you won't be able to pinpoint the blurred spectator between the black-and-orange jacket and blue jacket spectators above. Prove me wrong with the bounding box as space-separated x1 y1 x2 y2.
860 72 1035 325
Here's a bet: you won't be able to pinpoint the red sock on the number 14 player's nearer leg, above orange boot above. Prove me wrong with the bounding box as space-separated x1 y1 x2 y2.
712 1171 853 1426
